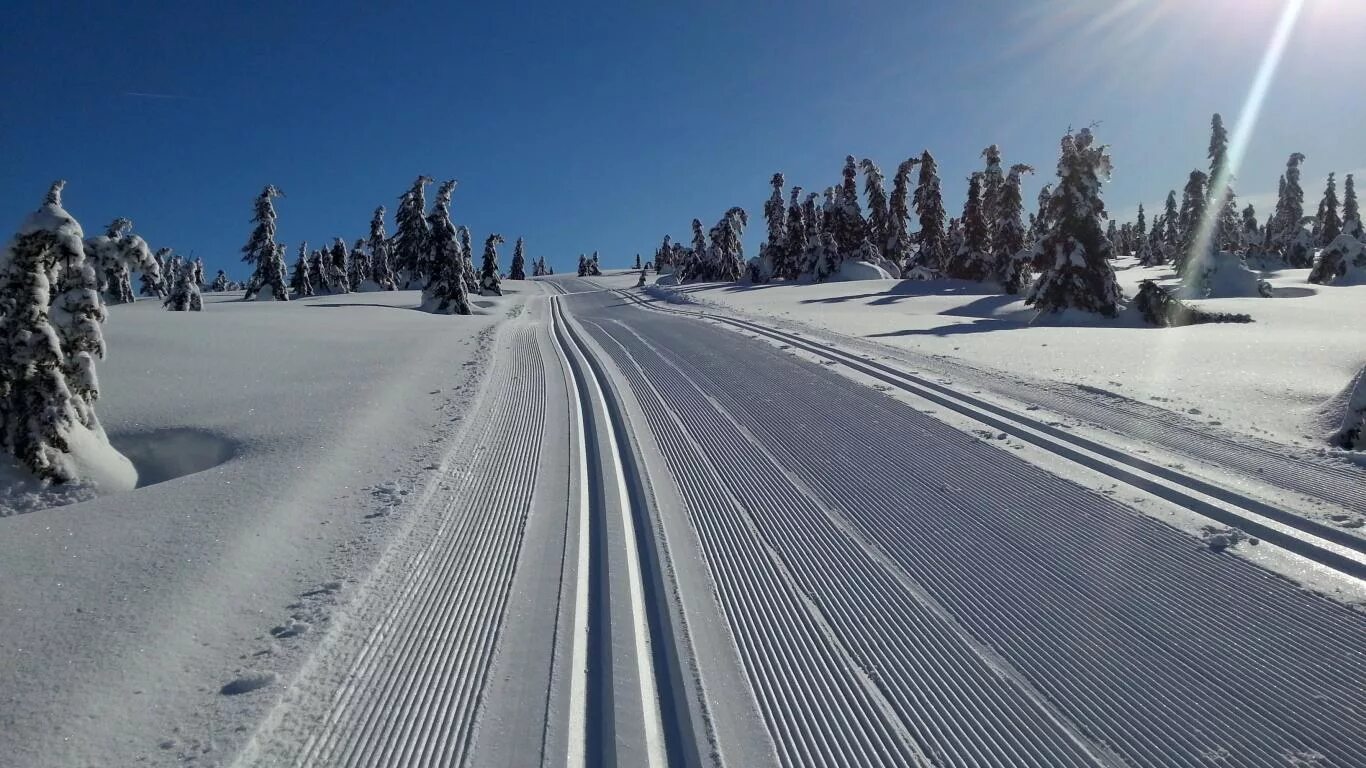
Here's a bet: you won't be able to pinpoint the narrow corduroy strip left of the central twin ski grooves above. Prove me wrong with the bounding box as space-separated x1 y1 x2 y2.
294 328 546 767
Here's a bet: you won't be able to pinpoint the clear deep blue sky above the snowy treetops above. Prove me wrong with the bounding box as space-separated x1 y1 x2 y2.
0 0 1366 279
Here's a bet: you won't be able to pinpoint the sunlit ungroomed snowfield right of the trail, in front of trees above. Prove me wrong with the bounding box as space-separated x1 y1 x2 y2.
633 260 1366 448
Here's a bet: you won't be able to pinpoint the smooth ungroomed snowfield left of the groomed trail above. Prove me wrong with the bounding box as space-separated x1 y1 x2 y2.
0 283 541 767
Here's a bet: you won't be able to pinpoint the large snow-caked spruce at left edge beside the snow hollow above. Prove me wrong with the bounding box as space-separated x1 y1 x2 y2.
0 182 138 491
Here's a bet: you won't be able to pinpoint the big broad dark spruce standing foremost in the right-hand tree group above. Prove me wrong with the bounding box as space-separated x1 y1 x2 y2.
1026 128 1123 317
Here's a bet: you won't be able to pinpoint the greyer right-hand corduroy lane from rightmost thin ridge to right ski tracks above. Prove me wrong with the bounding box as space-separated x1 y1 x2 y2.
570 291 1366 765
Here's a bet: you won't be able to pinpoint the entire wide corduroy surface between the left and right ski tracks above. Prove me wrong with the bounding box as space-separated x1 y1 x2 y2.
564 285 1366 767
